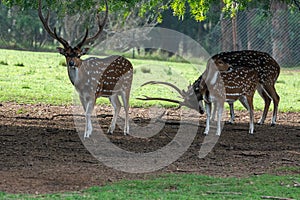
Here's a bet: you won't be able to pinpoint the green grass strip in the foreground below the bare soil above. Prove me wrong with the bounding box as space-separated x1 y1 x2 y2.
0 174 300 199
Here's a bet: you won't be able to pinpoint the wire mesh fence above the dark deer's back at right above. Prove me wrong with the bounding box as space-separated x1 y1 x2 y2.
208 9 300 66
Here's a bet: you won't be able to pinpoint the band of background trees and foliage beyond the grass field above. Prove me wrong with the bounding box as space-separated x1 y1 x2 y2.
0 0 300 64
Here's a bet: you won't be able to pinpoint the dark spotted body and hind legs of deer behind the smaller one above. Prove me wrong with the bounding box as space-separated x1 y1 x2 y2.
212 50 280 126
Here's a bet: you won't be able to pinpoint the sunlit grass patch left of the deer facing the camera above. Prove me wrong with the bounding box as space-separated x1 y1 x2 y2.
0 50 73 105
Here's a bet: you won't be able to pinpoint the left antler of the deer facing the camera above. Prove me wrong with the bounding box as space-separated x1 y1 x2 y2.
38 0 70 48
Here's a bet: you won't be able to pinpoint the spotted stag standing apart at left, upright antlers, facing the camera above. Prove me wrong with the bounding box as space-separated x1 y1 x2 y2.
38 0 133 138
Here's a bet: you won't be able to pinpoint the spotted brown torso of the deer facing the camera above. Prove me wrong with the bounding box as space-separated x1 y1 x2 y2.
69 56 133 99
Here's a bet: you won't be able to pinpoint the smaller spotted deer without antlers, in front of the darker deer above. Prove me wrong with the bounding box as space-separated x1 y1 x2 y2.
199 60 259 135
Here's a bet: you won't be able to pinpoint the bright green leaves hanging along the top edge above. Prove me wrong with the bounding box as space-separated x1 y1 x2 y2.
2 0 296 21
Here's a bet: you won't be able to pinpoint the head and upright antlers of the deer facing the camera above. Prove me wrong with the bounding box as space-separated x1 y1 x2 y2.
38 0 108 68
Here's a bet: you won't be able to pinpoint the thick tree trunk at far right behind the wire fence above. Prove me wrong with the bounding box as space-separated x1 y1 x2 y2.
271 0 291 65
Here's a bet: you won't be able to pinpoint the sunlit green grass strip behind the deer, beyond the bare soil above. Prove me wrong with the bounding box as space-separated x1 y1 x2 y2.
0 49 300 112
